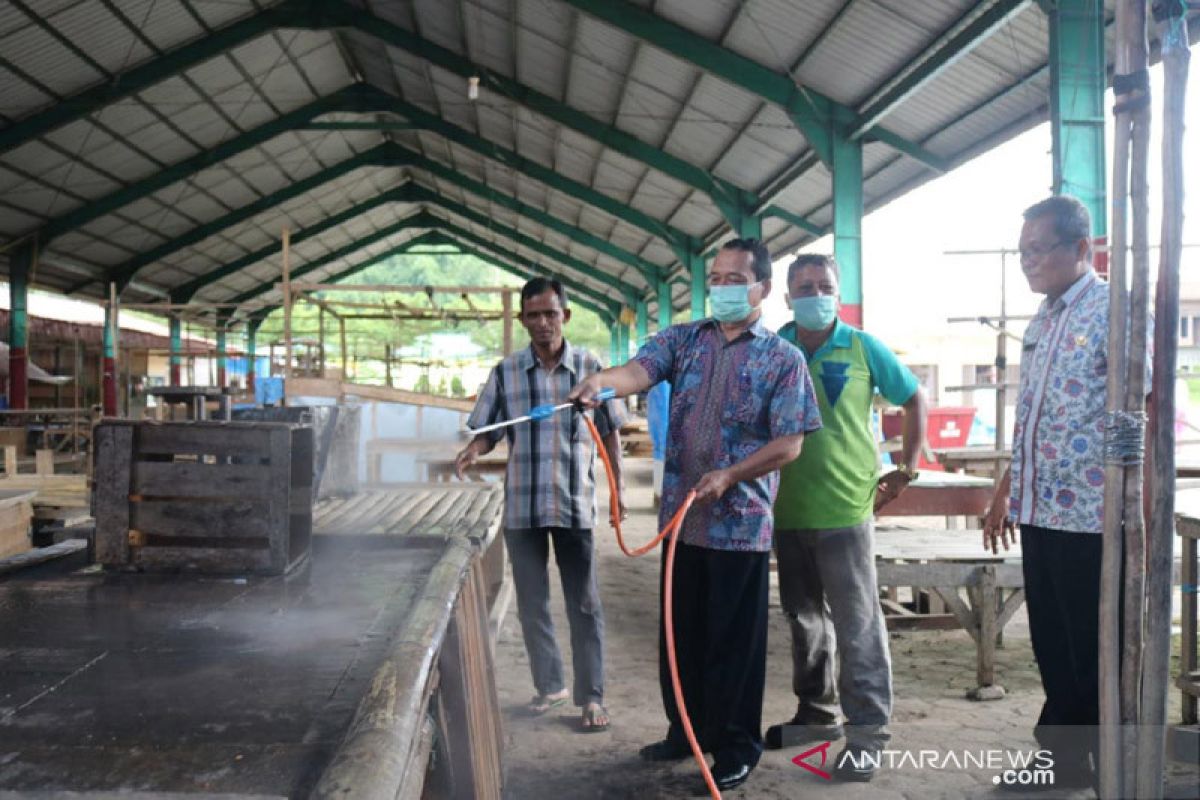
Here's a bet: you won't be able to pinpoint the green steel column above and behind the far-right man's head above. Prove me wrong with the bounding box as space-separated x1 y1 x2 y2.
1042 0 1109 241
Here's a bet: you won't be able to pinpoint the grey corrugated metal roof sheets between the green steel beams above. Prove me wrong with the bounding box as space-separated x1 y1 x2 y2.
0 0 1200 326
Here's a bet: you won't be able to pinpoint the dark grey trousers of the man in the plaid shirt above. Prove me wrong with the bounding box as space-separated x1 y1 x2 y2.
504 528 604 705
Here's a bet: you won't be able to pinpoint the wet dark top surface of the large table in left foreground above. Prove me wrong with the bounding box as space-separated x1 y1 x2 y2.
0 537 440 796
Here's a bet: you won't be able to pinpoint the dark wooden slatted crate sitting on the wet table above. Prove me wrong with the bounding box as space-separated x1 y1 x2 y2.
92 420 313 575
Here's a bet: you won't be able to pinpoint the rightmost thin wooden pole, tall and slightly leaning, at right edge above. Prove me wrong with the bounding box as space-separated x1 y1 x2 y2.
1136 6 1190 800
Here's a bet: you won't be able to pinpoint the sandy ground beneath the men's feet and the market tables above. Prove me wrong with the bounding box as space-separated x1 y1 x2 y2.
497 462 1200 800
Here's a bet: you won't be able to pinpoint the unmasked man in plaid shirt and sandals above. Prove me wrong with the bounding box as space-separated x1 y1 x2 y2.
455 278 625 733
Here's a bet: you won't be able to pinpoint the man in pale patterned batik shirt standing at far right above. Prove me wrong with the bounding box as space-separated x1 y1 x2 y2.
983 196 1150 789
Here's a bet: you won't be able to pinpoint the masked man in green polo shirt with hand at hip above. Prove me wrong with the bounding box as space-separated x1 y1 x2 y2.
766 255 926 781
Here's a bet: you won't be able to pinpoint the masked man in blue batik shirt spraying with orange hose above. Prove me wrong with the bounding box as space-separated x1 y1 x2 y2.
570 239 821 790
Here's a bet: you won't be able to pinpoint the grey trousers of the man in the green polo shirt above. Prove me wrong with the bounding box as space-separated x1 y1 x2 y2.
774 521 892 746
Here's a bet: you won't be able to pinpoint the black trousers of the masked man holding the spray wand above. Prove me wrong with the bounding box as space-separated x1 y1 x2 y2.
659 543 770 766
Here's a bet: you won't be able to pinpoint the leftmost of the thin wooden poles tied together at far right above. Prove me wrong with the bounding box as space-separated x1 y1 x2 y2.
1097 0 1136 799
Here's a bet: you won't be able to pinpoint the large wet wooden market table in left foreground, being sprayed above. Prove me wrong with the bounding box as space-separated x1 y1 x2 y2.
0 485 503 800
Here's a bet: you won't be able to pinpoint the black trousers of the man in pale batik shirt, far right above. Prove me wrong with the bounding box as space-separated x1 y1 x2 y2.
1021 525 1102 766
